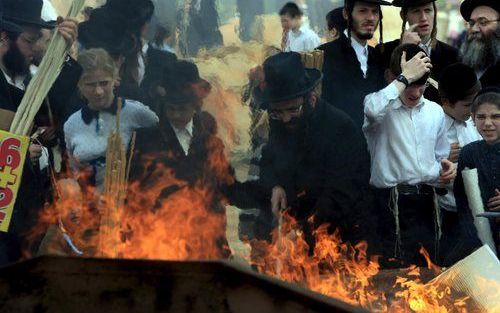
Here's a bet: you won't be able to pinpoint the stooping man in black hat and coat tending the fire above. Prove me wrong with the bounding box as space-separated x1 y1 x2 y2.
254 52 376 249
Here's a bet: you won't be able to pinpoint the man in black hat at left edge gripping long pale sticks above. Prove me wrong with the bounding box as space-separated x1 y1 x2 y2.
0 0 81 265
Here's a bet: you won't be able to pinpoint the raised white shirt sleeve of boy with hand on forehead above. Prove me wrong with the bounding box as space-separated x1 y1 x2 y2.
363 83 399 132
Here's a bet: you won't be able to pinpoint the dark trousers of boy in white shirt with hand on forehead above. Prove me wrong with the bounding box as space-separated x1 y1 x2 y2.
374 189 439 268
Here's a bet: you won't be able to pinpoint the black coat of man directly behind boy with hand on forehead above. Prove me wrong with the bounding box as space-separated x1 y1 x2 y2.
375 39 460 103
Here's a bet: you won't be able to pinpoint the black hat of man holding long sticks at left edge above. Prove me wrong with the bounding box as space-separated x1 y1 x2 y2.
3 0 54 29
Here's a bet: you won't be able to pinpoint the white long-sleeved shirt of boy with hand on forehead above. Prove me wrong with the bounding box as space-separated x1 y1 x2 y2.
363 84 450 188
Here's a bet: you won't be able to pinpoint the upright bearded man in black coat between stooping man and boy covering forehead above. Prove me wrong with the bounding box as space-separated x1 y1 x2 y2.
318 0 390 129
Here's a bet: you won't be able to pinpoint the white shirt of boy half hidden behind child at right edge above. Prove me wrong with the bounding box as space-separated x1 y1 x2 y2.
438 114 482 212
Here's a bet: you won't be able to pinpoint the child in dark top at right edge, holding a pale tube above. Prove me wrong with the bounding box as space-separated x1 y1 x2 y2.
454 87 500 264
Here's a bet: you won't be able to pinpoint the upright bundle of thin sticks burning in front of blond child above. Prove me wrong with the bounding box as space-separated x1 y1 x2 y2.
98 99 135 257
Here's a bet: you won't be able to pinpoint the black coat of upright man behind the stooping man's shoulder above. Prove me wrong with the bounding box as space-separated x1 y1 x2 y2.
318 34 387 129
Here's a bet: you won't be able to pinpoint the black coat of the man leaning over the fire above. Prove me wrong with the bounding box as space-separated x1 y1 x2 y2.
259 100 376 247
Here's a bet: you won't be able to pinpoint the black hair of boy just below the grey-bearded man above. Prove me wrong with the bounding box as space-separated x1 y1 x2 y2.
439 63 481 105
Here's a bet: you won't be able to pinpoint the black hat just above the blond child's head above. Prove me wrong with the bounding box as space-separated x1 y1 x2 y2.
78 8 136 56
